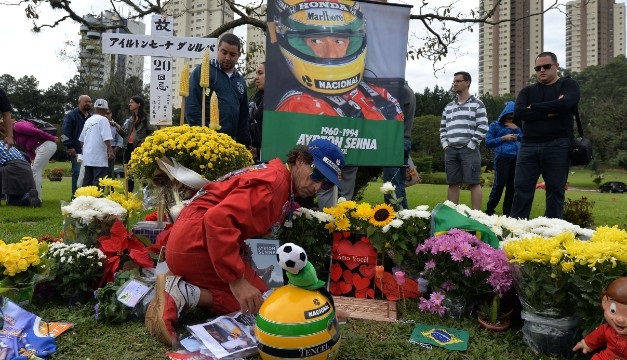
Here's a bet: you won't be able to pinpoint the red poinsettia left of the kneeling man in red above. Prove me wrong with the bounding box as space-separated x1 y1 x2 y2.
98 220 155 287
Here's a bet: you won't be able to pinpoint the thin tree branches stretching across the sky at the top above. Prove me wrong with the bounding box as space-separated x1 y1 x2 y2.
4 0 565 70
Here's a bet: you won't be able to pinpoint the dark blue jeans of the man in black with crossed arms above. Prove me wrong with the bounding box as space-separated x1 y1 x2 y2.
511 138 570 219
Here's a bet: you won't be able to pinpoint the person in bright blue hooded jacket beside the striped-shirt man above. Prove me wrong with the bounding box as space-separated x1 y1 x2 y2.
485 101 522 216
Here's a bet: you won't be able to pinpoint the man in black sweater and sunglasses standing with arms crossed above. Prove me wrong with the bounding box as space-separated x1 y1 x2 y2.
510 52 580 219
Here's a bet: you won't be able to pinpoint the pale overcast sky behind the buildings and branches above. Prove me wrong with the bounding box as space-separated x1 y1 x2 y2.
0 0 625 93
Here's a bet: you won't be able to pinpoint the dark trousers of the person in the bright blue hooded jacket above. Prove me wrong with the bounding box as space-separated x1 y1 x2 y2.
485 155 516 216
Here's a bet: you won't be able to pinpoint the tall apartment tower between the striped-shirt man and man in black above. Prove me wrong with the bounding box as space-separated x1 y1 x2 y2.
480 0 544 96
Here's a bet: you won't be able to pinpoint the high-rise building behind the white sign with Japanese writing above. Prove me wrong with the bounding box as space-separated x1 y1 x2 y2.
78 10 146 90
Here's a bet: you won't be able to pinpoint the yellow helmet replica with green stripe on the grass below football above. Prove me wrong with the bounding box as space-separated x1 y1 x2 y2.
255 285 340 360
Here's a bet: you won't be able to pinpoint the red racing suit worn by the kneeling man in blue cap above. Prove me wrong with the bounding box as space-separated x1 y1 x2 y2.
158 159 291 313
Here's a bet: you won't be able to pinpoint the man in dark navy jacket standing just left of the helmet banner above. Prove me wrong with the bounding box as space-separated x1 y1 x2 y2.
185 34 250 146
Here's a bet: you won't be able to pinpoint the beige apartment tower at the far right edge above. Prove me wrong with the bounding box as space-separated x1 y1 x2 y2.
566 0 625 72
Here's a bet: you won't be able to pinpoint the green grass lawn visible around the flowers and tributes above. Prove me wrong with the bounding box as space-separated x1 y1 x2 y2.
0 163 627 360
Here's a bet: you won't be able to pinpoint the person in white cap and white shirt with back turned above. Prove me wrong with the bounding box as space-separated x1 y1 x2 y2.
78 99 113 186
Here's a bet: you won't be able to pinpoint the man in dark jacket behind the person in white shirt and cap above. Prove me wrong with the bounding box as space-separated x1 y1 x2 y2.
61 95 91 197
